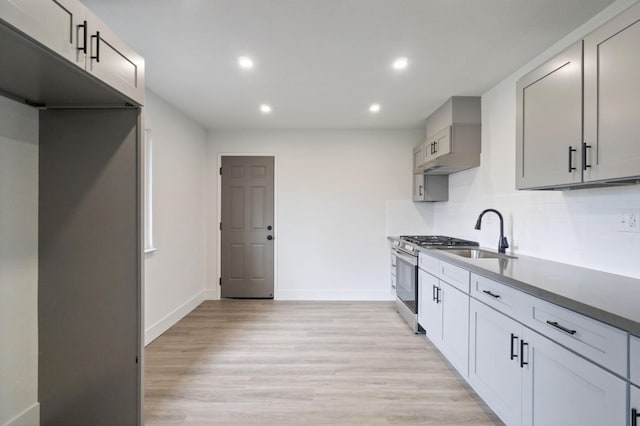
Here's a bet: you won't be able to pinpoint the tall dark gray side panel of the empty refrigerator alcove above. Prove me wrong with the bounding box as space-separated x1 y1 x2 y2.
38 109 142 426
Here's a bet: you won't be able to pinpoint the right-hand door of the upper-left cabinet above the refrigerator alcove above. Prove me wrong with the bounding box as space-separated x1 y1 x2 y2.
87 10 144 105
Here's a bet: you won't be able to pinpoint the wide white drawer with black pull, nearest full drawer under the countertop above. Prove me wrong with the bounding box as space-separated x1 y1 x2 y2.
525 298 627 377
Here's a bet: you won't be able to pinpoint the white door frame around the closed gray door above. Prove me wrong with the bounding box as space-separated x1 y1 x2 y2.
216 152 280 300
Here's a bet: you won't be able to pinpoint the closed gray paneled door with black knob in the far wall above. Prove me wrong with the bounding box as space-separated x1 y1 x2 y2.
220 156 275 298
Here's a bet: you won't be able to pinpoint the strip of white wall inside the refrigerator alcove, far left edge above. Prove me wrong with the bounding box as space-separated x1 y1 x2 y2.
0 97 39 426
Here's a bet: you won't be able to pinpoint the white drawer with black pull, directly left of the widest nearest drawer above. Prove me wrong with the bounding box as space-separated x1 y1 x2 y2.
471 274 533 321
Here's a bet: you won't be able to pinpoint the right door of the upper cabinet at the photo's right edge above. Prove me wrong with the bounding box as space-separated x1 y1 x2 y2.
584 3 640 181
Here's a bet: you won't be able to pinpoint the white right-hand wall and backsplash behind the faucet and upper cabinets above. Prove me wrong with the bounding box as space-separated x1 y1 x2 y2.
430 0 640 278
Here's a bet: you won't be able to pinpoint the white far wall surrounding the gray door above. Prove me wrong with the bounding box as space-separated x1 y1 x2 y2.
207 130 424 300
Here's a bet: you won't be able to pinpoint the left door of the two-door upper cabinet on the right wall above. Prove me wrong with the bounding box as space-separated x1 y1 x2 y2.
516 42 582 189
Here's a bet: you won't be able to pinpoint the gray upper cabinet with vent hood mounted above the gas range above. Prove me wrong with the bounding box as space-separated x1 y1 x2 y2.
414 96 481 175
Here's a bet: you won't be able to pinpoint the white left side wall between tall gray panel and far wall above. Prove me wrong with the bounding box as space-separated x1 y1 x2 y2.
144 91 207 343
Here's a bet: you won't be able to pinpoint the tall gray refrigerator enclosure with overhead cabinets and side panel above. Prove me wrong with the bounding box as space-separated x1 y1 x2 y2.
0 0 144 426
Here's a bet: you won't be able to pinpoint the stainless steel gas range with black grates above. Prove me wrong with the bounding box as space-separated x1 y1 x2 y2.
393 235 478 333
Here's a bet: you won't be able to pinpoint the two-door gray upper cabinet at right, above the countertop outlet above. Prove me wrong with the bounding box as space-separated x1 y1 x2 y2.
516 3 640 189
